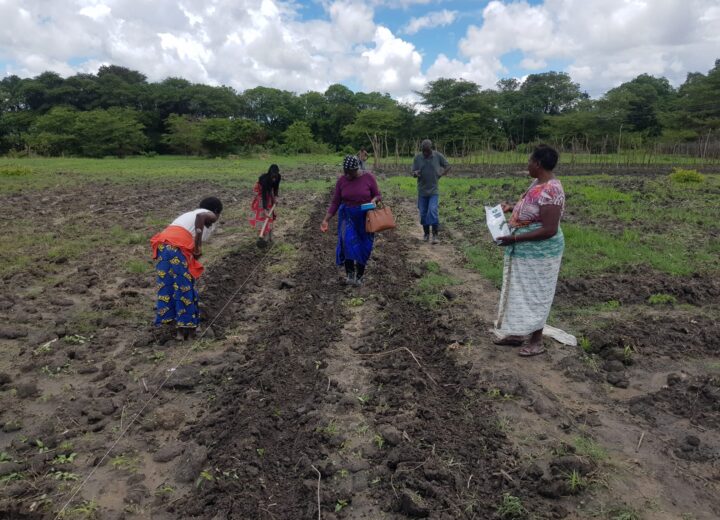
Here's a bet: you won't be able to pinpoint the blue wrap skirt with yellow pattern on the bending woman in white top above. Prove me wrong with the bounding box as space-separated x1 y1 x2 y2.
155 244 200 328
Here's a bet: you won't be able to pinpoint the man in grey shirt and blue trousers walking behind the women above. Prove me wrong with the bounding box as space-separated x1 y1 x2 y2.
413 139 451 244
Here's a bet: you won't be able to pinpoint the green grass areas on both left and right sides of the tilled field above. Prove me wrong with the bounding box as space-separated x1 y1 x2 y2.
0 154 720 283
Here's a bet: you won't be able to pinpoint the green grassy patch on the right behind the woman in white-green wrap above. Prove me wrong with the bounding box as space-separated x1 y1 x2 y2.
387 171 720 283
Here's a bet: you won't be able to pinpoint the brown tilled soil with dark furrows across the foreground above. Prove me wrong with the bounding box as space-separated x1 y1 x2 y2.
0 177 720 520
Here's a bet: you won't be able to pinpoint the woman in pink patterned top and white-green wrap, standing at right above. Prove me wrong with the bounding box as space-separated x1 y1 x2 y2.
496 145 565 356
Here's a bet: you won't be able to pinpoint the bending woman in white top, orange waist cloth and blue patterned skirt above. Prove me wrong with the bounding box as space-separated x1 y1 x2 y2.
150 197 222 339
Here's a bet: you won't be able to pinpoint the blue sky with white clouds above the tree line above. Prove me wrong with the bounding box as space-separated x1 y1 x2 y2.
0 0 720 102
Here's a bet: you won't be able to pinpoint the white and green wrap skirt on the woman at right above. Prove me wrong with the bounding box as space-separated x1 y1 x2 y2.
495 224 565 337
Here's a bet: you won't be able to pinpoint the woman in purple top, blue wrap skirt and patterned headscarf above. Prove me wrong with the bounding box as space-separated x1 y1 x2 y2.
320 155 382 287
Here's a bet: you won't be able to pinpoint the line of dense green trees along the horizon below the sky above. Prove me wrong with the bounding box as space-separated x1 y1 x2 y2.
0 60 720 157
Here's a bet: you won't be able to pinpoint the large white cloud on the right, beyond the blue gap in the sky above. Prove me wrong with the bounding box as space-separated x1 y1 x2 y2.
444 0 720 95
